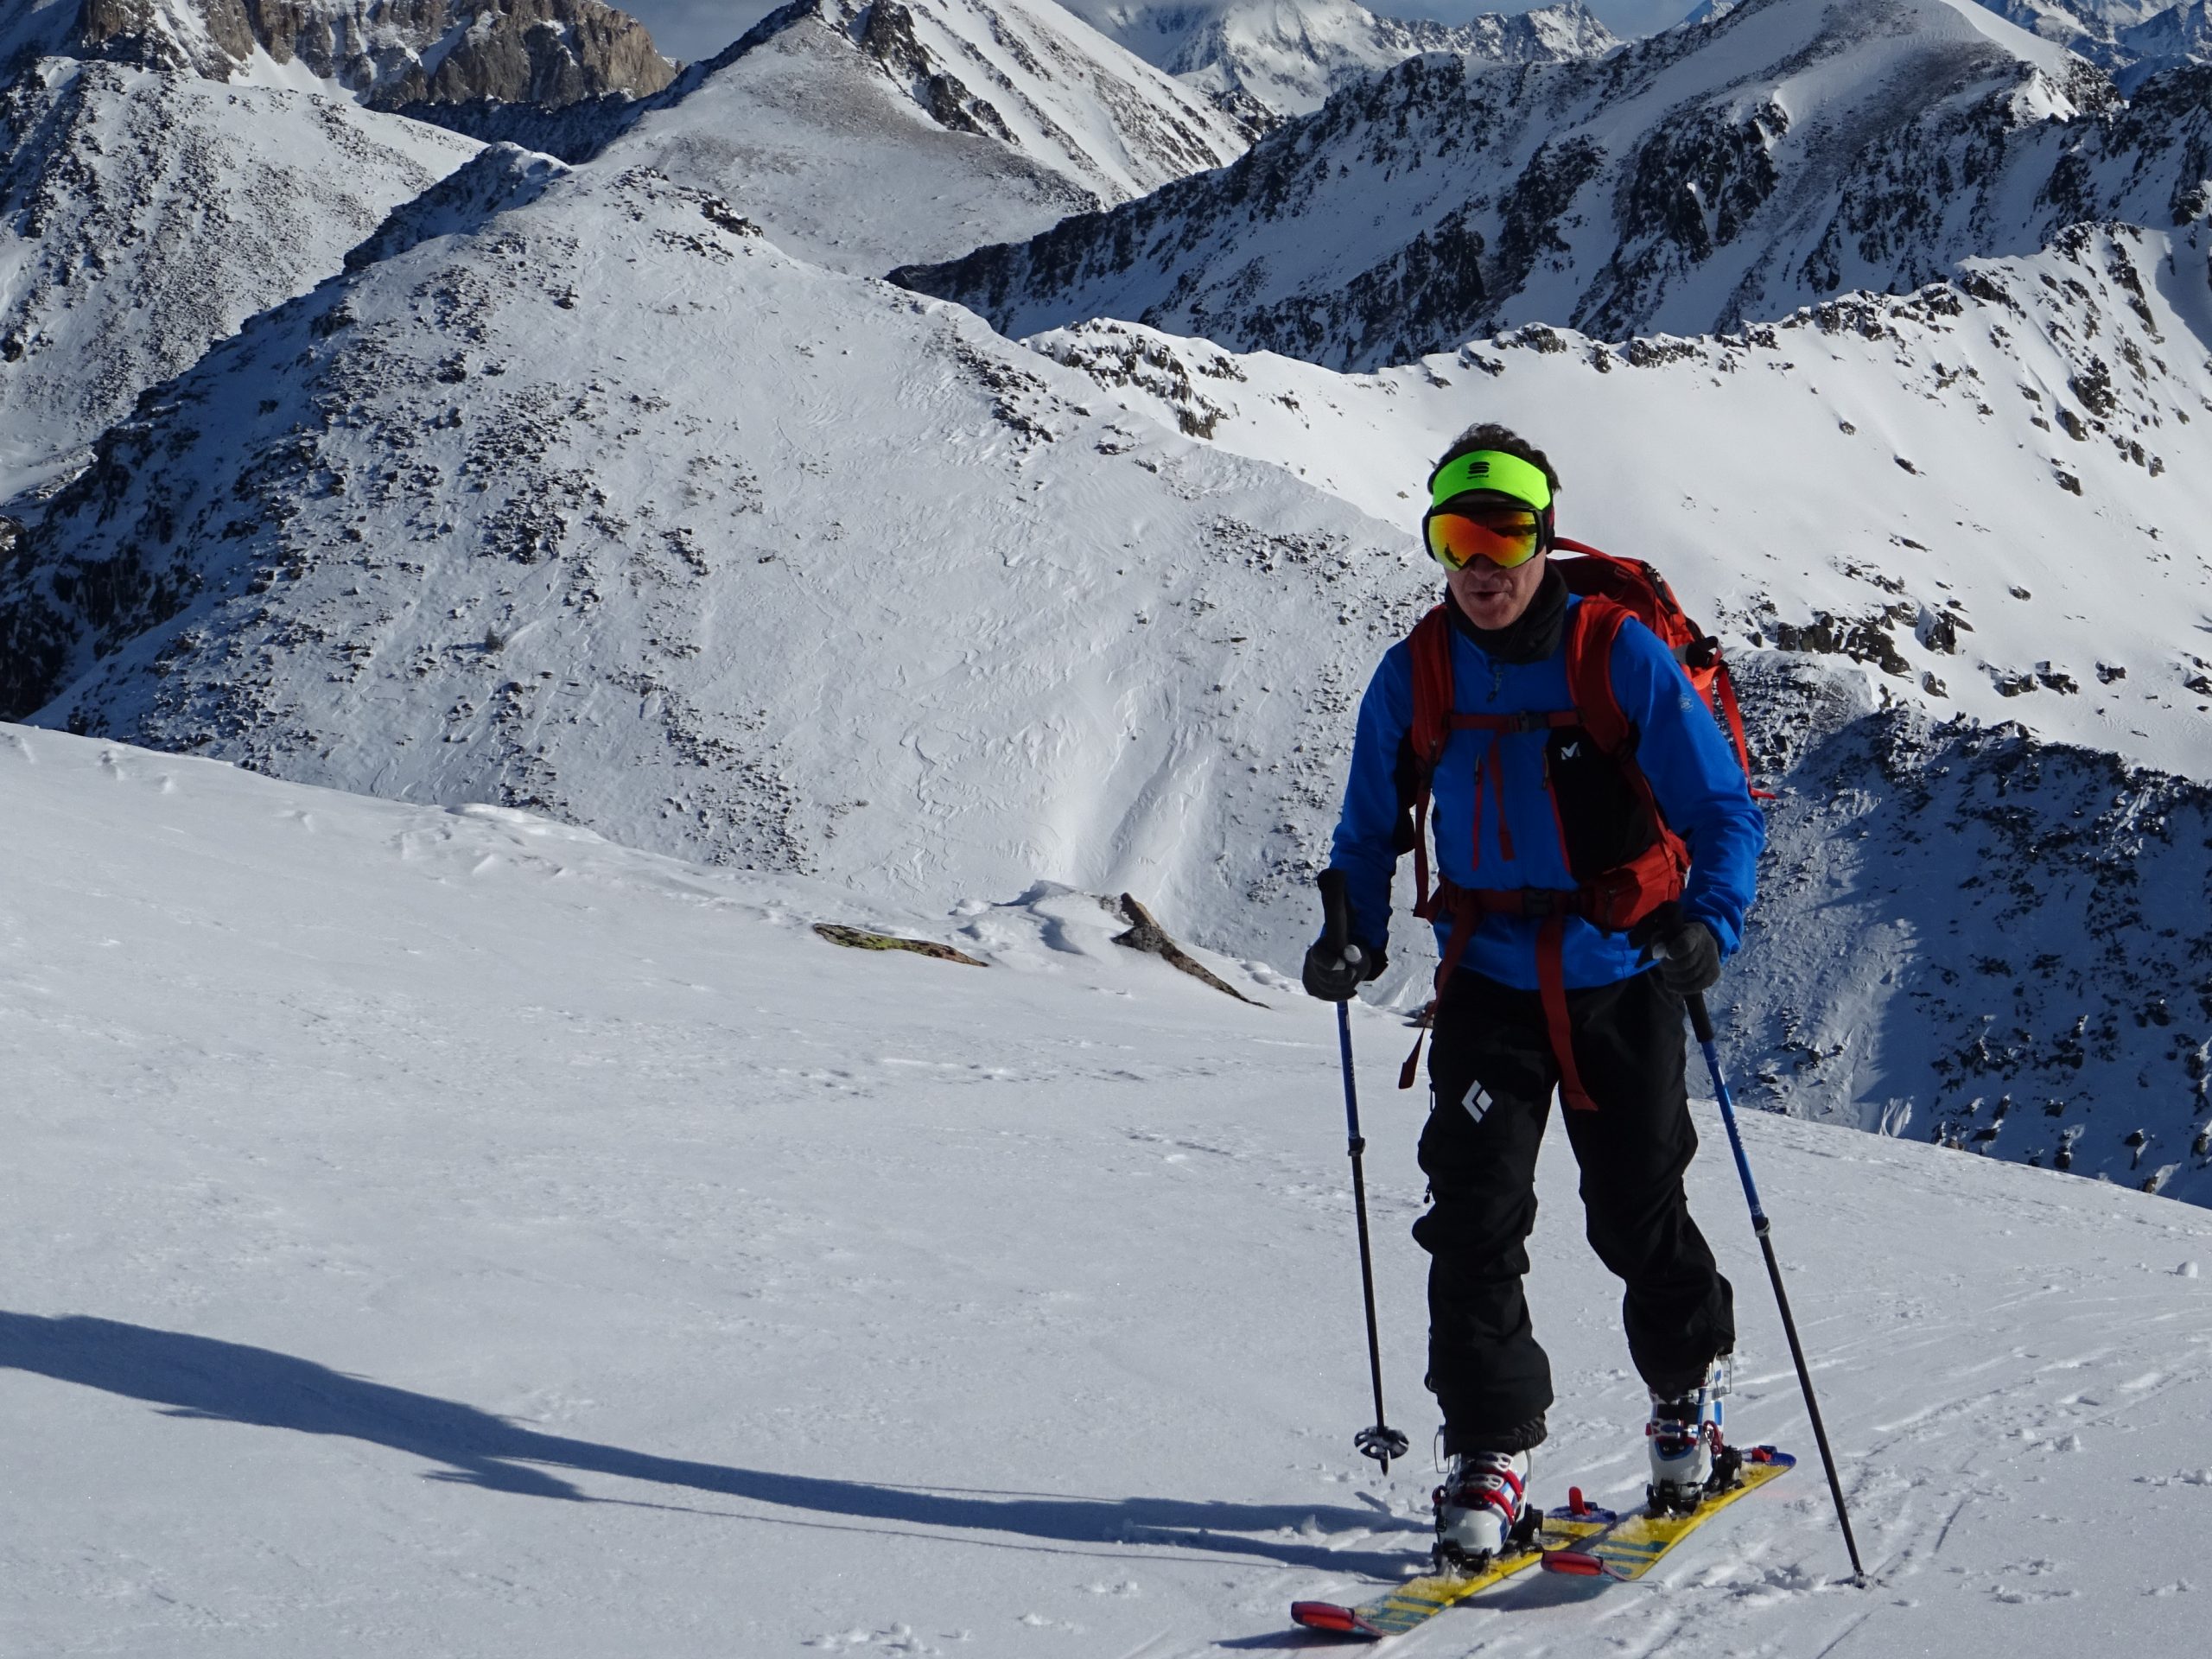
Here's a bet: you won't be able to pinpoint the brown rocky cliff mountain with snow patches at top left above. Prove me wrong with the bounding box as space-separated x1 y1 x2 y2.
54 0 675 108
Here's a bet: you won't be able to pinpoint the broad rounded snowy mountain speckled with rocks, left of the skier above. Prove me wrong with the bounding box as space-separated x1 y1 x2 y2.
0 153 1427 960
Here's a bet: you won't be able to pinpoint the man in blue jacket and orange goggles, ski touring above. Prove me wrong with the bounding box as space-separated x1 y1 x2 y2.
1305 425 1765 1564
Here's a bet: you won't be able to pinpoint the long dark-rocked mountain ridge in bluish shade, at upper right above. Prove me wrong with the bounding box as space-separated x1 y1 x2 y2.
900 0 2212 367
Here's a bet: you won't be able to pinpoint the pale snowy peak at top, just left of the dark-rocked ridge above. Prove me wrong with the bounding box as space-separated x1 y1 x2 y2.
597 0 1248 276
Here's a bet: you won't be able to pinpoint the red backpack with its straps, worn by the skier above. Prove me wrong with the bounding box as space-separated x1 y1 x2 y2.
1398 537 1752 1110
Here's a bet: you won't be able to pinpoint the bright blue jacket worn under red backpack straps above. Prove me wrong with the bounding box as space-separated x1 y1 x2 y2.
1330 597 1765 991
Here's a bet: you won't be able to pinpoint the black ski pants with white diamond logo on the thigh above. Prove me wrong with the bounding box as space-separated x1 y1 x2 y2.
1414 969 1737 1451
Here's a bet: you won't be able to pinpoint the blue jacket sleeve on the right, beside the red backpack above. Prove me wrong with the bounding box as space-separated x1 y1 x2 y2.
1612 620 1767 956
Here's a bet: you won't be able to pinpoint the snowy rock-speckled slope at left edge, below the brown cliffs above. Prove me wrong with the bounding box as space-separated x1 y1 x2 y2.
0 58 478 500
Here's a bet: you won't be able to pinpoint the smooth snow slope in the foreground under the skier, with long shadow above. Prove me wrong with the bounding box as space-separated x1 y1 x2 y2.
0 728 2212 1659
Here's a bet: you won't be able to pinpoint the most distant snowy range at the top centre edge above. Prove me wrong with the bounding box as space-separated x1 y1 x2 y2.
1044 0 1619 124
